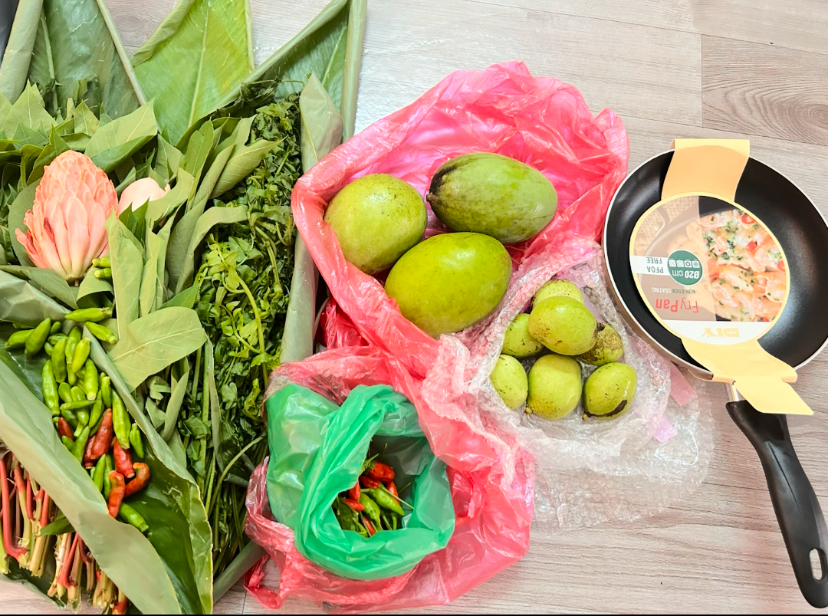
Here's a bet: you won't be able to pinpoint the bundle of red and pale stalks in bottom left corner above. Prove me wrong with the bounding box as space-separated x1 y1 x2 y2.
0 453 129 614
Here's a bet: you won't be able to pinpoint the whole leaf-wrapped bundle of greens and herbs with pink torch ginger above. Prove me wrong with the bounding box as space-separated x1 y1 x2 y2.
0 0 364 613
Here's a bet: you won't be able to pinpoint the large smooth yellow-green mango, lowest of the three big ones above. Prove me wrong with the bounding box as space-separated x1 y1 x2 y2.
385 233 512 338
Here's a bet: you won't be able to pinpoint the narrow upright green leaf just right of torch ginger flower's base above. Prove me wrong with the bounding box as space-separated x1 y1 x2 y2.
106 215 146 336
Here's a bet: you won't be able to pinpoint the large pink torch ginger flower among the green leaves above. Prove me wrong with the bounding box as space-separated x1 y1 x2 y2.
15 151 118 282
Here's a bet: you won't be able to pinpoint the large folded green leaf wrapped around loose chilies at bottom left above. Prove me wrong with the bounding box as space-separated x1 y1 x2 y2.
0 272 212 614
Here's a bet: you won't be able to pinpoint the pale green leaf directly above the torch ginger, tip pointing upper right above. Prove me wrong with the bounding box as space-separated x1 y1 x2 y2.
86 101 158 173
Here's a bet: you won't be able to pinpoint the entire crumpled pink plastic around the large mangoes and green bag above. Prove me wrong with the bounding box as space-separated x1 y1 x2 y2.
246 62 629 611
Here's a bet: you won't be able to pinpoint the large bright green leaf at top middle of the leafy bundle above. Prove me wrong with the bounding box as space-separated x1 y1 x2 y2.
132 0 253 143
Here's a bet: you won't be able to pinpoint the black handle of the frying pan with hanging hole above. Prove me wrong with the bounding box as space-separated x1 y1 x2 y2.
727 400 828 607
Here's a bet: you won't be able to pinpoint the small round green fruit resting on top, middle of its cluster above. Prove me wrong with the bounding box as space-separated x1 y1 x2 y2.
529 296 598 355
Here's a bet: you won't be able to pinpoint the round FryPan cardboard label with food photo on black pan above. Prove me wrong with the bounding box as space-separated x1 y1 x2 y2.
630 195 790 344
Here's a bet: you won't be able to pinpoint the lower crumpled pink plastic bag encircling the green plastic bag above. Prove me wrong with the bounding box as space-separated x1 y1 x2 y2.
245 346 534 612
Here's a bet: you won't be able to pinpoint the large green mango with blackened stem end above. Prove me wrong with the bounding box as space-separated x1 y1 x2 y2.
426 152 558 244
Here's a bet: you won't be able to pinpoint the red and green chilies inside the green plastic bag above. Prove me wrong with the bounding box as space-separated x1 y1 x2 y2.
333 455 413 537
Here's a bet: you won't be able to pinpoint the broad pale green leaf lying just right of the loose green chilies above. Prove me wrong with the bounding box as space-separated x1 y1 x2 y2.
109 308 206 389
